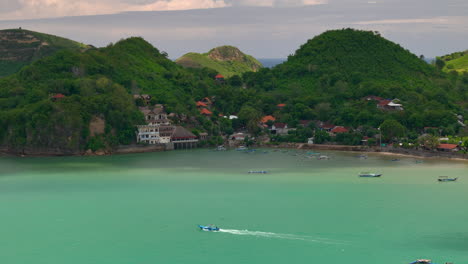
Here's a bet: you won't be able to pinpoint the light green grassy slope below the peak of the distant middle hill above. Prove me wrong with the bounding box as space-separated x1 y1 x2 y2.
176 46 262 77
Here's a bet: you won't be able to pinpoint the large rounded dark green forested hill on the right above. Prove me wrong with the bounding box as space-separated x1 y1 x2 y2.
239 29 468 131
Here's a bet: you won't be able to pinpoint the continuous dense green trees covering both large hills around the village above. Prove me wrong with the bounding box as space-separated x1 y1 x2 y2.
0 29 468 153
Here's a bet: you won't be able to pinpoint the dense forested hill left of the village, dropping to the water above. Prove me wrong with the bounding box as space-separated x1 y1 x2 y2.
0 38 216 154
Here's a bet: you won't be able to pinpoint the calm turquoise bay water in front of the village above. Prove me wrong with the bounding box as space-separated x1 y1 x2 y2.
0 150 468 264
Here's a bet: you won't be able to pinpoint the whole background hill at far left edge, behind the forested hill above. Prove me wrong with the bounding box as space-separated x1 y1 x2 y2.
0 29 88 77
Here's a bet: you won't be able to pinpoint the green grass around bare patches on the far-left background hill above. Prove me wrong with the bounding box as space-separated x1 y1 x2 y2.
0 29 88 77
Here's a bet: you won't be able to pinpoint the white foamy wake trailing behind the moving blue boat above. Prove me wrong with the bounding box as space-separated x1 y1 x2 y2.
219 229 345 245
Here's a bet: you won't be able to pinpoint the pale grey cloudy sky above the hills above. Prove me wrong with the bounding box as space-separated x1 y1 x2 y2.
0 0 468 58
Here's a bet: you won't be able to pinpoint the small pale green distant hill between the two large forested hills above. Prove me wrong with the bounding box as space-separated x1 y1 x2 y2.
176 46 263 77
